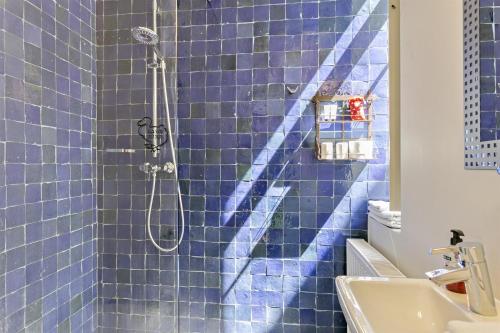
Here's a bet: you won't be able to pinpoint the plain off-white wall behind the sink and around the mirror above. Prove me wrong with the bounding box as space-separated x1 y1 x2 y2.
397 0 500 298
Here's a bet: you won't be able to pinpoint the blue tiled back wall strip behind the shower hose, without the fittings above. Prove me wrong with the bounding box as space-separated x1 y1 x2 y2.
97 0 177 333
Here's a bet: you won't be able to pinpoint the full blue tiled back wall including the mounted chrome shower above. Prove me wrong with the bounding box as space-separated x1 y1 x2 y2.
94 0 388 333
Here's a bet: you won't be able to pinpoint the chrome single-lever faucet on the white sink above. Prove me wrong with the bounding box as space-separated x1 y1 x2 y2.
425 242 497 316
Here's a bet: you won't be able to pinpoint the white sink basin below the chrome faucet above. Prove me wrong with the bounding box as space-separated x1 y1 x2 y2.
336 276 498 333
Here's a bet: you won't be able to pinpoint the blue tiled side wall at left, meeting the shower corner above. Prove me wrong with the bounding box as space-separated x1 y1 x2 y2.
0 0 97 333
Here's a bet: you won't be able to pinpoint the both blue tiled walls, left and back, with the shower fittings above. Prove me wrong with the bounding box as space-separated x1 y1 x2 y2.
0 0 389 333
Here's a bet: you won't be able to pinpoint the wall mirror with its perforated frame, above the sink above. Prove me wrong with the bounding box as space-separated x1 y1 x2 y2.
464 0 500 173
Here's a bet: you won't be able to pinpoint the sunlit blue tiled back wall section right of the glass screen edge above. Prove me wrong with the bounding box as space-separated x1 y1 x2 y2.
178 0 388 333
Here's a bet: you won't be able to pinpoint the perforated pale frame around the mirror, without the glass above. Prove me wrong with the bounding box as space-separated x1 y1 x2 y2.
464 0 500 169
